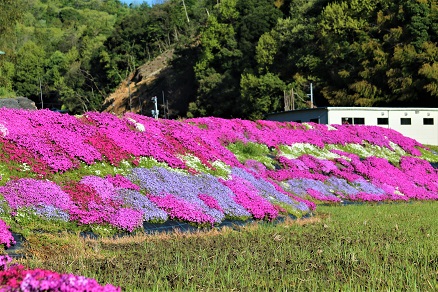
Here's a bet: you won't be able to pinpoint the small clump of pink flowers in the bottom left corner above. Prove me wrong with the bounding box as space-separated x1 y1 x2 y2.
0 255 121 292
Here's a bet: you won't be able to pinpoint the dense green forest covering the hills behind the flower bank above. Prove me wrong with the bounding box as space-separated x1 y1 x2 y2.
0 0 438 119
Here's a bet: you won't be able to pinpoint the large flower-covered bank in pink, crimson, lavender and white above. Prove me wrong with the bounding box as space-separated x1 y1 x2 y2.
0 109 438 245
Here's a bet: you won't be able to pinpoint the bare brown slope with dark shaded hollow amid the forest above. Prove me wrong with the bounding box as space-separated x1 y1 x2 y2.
101 50 195 118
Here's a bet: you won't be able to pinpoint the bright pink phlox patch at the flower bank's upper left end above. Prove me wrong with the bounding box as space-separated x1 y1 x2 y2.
0 109 99 171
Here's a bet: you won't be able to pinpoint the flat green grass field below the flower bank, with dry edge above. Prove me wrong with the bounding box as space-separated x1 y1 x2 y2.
18 202 438 291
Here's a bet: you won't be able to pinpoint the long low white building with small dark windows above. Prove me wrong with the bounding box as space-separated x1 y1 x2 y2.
266 107 438 146
